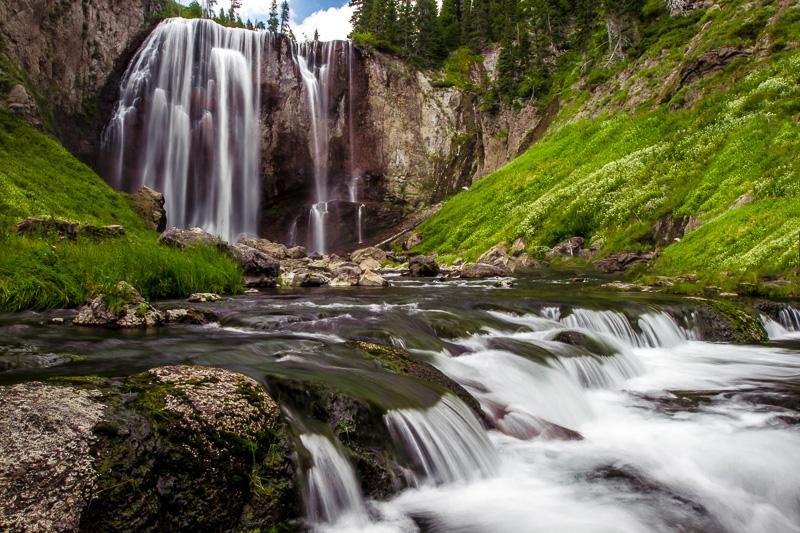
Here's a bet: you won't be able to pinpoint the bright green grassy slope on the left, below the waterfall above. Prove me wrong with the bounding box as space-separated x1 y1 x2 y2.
0 111 241 311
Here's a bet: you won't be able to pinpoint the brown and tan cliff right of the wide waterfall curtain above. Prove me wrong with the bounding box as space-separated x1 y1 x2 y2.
260 40 547 249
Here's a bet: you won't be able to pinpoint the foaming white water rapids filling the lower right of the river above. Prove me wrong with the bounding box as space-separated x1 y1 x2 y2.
312 308 800 533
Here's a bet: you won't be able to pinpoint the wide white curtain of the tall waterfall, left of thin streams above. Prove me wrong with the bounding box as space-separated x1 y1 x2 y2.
103 19 270 241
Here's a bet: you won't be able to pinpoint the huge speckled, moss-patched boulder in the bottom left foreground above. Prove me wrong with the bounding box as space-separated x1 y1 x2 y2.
0 366 300 531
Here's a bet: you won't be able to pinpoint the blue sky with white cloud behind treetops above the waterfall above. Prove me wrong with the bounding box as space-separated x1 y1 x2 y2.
180 0 353 41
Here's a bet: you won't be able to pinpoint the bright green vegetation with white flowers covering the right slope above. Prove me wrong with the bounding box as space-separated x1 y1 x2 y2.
419 47 800 286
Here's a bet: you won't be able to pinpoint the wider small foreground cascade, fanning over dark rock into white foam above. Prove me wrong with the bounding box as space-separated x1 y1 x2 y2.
384 395 498 484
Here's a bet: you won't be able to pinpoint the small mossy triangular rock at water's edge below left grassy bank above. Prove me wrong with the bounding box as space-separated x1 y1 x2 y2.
72 281 164 328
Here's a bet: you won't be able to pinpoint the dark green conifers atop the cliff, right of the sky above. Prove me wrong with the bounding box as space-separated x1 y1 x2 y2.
350 0 677 100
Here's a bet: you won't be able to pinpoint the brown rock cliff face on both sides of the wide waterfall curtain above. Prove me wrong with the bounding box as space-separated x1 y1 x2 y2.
0 7 539 249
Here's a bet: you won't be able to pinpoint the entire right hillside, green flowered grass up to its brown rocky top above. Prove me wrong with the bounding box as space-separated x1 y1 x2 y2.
419 2 800 296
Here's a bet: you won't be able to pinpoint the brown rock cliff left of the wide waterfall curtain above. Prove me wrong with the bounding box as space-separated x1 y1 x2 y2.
0 0 158 162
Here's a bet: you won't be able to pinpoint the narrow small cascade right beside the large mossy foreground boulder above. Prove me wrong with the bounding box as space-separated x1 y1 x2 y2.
300 434 367 524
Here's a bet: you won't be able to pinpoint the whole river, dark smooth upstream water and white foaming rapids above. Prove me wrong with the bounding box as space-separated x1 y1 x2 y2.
0 278 800 533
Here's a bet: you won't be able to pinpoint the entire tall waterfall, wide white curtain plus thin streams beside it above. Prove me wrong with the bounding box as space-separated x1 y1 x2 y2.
103 19 367 247
